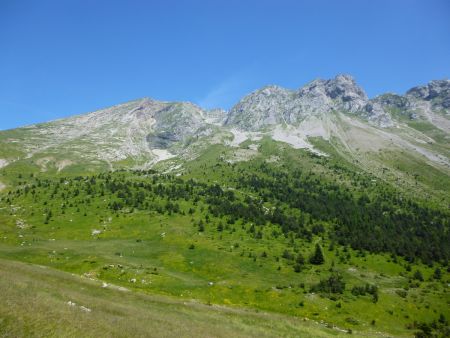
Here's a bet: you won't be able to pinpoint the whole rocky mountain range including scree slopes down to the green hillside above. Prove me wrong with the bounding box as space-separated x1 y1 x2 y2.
0 75 450 195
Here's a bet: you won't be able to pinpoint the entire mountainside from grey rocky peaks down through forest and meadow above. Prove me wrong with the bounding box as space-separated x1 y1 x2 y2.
0 75 450 337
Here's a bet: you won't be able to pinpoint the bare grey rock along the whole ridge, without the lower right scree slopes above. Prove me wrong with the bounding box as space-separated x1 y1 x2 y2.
0 75 450 170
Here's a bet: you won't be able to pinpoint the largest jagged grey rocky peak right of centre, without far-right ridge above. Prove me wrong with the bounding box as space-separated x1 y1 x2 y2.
225 75 393 131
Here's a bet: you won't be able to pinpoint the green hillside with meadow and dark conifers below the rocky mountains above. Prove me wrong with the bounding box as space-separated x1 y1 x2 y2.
0 139 450 337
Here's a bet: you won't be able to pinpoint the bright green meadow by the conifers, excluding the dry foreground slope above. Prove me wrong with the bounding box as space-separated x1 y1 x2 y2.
0 142 450 336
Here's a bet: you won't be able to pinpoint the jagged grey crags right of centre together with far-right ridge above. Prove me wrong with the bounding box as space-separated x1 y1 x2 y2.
226 75 450 131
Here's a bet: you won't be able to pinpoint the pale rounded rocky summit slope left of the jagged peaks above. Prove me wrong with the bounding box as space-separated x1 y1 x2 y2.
7 98 217 163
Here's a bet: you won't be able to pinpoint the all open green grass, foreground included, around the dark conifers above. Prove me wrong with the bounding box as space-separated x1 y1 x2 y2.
0 139 450 337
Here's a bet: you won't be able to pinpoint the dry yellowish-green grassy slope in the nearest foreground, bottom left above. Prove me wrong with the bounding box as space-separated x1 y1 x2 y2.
0 260 338 337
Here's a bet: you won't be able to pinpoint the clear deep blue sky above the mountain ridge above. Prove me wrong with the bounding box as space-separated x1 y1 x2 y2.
0 0 450 129
